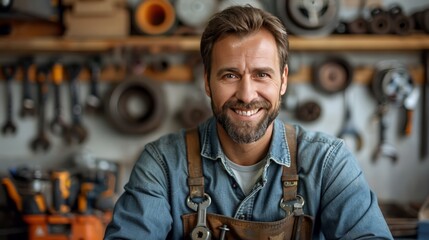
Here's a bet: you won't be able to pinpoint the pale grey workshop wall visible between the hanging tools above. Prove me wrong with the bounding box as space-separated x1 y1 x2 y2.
0 0 429 208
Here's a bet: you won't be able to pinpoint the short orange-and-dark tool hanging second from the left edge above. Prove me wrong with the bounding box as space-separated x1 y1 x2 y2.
21 57 36 117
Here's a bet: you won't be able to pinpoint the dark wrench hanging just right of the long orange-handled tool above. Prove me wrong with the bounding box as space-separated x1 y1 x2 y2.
65 64 88 144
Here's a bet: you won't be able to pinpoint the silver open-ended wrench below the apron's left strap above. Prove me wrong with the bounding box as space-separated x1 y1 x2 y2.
186 194 211 240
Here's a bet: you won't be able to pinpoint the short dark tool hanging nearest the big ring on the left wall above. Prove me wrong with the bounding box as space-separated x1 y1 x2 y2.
85 58 103 113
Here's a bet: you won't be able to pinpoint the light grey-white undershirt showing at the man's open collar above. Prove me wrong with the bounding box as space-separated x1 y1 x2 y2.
226 158 266 195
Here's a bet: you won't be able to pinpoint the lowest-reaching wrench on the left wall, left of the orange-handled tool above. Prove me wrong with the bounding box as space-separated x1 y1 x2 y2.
30 66 51 151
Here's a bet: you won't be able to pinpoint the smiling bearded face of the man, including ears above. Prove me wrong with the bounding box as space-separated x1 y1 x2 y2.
205 30 288 143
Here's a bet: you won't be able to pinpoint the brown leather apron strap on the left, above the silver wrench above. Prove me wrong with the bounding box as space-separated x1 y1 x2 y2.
186 128 204 199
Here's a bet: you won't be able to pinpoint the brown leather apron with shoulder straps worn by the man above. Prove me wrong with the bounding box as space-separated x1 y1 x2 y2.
182 125 313 240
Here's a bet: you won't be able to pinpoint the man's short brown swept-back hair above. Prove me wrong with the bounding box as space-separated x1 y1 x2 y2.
200 5 289 79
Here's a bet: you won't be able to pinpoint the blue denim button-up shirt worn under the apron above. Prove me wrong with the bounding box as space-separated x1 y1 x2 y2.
105 118 393 239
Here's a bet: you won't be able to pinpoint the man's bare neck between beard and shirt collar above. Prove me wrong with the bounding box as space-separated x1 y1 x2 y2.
217 123 274 166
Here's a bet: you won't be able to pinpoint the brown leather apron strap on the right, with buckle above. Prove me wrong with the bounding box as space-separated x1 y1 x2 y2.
282 124 298 201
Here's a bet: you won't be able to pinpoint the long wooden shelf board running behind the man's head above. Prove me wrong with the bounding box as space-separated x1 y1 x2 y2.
0 34 429 53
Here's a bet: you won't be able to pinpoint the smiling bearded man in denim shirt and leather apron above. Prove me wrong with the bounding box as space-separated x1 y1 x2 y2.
105 6 392 239
